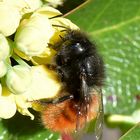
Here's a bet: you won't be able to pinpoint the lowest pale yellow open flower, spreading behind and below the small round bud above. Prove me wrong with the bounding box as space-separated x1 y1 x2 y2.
0 65 61 119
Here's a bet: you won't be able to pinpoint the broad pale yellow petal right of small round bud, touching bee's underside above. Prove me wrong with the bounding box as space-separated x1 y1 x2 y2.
23 65 61 101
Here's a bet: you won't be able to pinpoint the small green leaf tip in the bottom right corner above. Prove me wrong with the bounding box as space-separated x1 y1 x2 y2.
119 123 140 140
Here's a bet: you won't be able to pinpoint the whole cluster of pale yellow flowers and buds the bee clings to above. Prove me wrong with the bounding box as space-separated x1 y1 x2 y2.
0 0 78 119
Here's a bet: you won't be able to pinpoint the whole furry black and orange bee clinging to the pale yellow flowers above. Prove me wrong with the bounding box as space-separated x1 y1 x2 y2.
34 16 105 140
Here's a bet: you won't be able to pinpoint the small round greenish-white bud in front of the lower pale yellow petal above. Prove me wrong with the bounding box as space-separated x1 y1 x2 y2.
6 65 32 94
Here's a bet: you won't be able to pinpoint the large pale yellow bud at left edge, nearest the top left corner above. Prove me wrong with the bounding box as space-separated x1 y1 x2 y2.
0 4 21 36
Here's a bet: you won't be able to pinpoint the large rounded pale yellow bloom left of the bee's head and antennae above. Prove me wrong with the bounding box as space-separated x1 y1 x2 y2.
15 15 54 56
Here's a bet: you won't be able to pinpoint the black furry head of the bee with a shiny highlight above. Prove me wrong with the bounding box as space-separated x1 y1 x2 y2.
56 30 93 65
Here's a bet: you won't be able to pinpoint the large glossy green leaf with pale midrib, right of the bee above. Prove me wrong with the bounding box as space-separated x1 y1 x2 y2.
68 0 140 114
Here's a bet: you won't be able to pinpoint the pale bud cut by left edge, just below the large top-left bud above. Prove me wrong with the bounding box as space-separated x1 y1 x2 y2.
0 33 10 61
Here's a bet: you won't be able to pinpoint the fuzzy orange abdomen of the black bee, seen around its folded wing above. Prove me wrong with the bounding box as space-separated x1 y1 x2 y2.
42 96 99 133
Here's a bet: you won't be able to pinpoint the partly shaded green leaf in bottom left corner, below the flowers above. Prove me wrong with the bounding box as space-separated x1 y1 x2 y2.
0 113 59 140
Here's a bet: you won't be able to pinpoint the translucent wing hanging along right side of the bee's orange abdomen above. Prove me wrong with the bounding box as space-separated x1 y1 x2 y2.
95 89 104 140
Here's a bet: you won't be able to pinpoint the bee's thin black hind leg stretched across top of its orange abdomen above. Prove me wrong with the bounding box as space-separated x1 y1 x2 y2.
34 95 73 106
